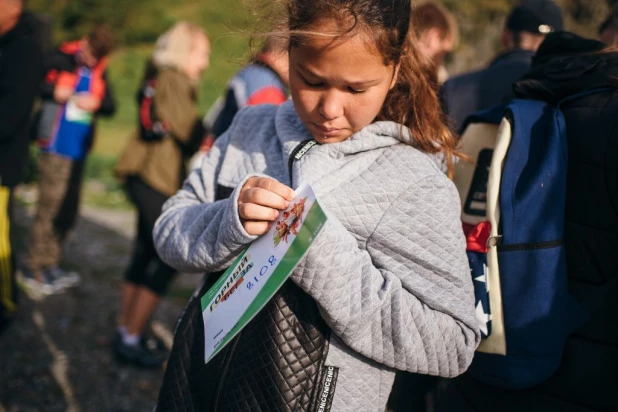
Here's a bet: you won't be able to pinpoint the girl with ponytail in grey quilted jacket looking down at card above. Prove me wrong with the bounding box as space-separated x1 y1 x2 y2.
154 0 480 412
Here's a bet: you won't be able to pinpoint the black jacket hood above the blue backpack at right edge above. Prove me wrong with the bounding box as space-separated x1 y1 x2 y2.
513 32 618 104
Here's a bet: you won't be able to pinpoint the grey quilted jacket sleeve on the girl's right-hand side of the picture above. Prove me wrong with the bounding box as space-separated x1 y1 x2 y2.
292 176 480 377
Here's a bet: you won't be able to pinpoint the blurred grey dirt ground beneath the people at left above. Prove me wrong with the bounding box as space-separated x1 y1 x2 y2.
0 201 199 412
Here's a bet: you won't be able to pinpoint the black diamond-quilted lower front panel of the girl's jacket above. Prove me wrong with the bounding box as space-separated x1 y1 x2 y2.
220 282 328 412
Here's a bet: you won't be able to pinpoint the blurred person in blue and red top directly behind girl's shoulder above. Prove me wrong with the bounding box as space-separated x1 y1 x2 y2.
191 35 289 169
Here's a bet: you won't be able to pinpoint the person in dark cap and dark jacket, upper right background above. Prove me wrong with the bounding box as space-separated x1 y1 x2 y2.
441 0 563 132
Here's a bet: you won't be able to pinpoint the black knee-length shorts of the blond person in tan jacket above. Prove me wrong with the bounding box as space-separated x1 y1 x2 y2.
125 177 176 296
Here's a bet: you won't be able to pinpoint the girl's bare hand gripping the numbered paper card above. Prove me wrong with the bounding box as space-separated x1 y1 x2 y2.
238 177 294 236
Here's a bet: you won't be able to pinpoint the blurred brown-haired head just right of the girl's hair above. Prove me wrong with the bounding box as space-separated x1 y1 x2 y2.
411 2 459 84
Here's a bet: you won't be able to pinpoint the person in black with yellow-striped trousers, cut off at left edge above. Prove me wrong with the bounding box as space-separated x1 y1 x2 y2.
0 0 43 333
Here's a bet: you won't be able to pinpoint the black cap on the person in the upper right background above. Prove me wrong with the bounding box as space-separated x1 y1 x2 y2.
506 0 563 35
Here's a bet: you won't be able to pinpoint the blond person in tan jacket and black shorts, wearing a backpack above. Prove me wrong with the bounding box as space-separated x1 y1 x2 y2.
114 22 210 367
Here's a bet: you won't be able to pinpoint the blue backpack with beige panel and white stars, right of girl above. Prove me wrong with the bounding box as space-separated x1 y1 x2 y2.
454 93 604 389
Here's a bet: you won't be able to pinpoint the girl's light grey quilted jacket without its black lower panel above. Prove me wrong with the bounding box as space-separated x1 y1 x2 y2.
154 102 480 412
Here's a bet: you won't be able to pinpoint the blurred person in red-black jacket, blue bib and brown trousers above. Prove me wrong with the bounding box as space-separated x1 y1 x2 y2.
22 26 115 294
